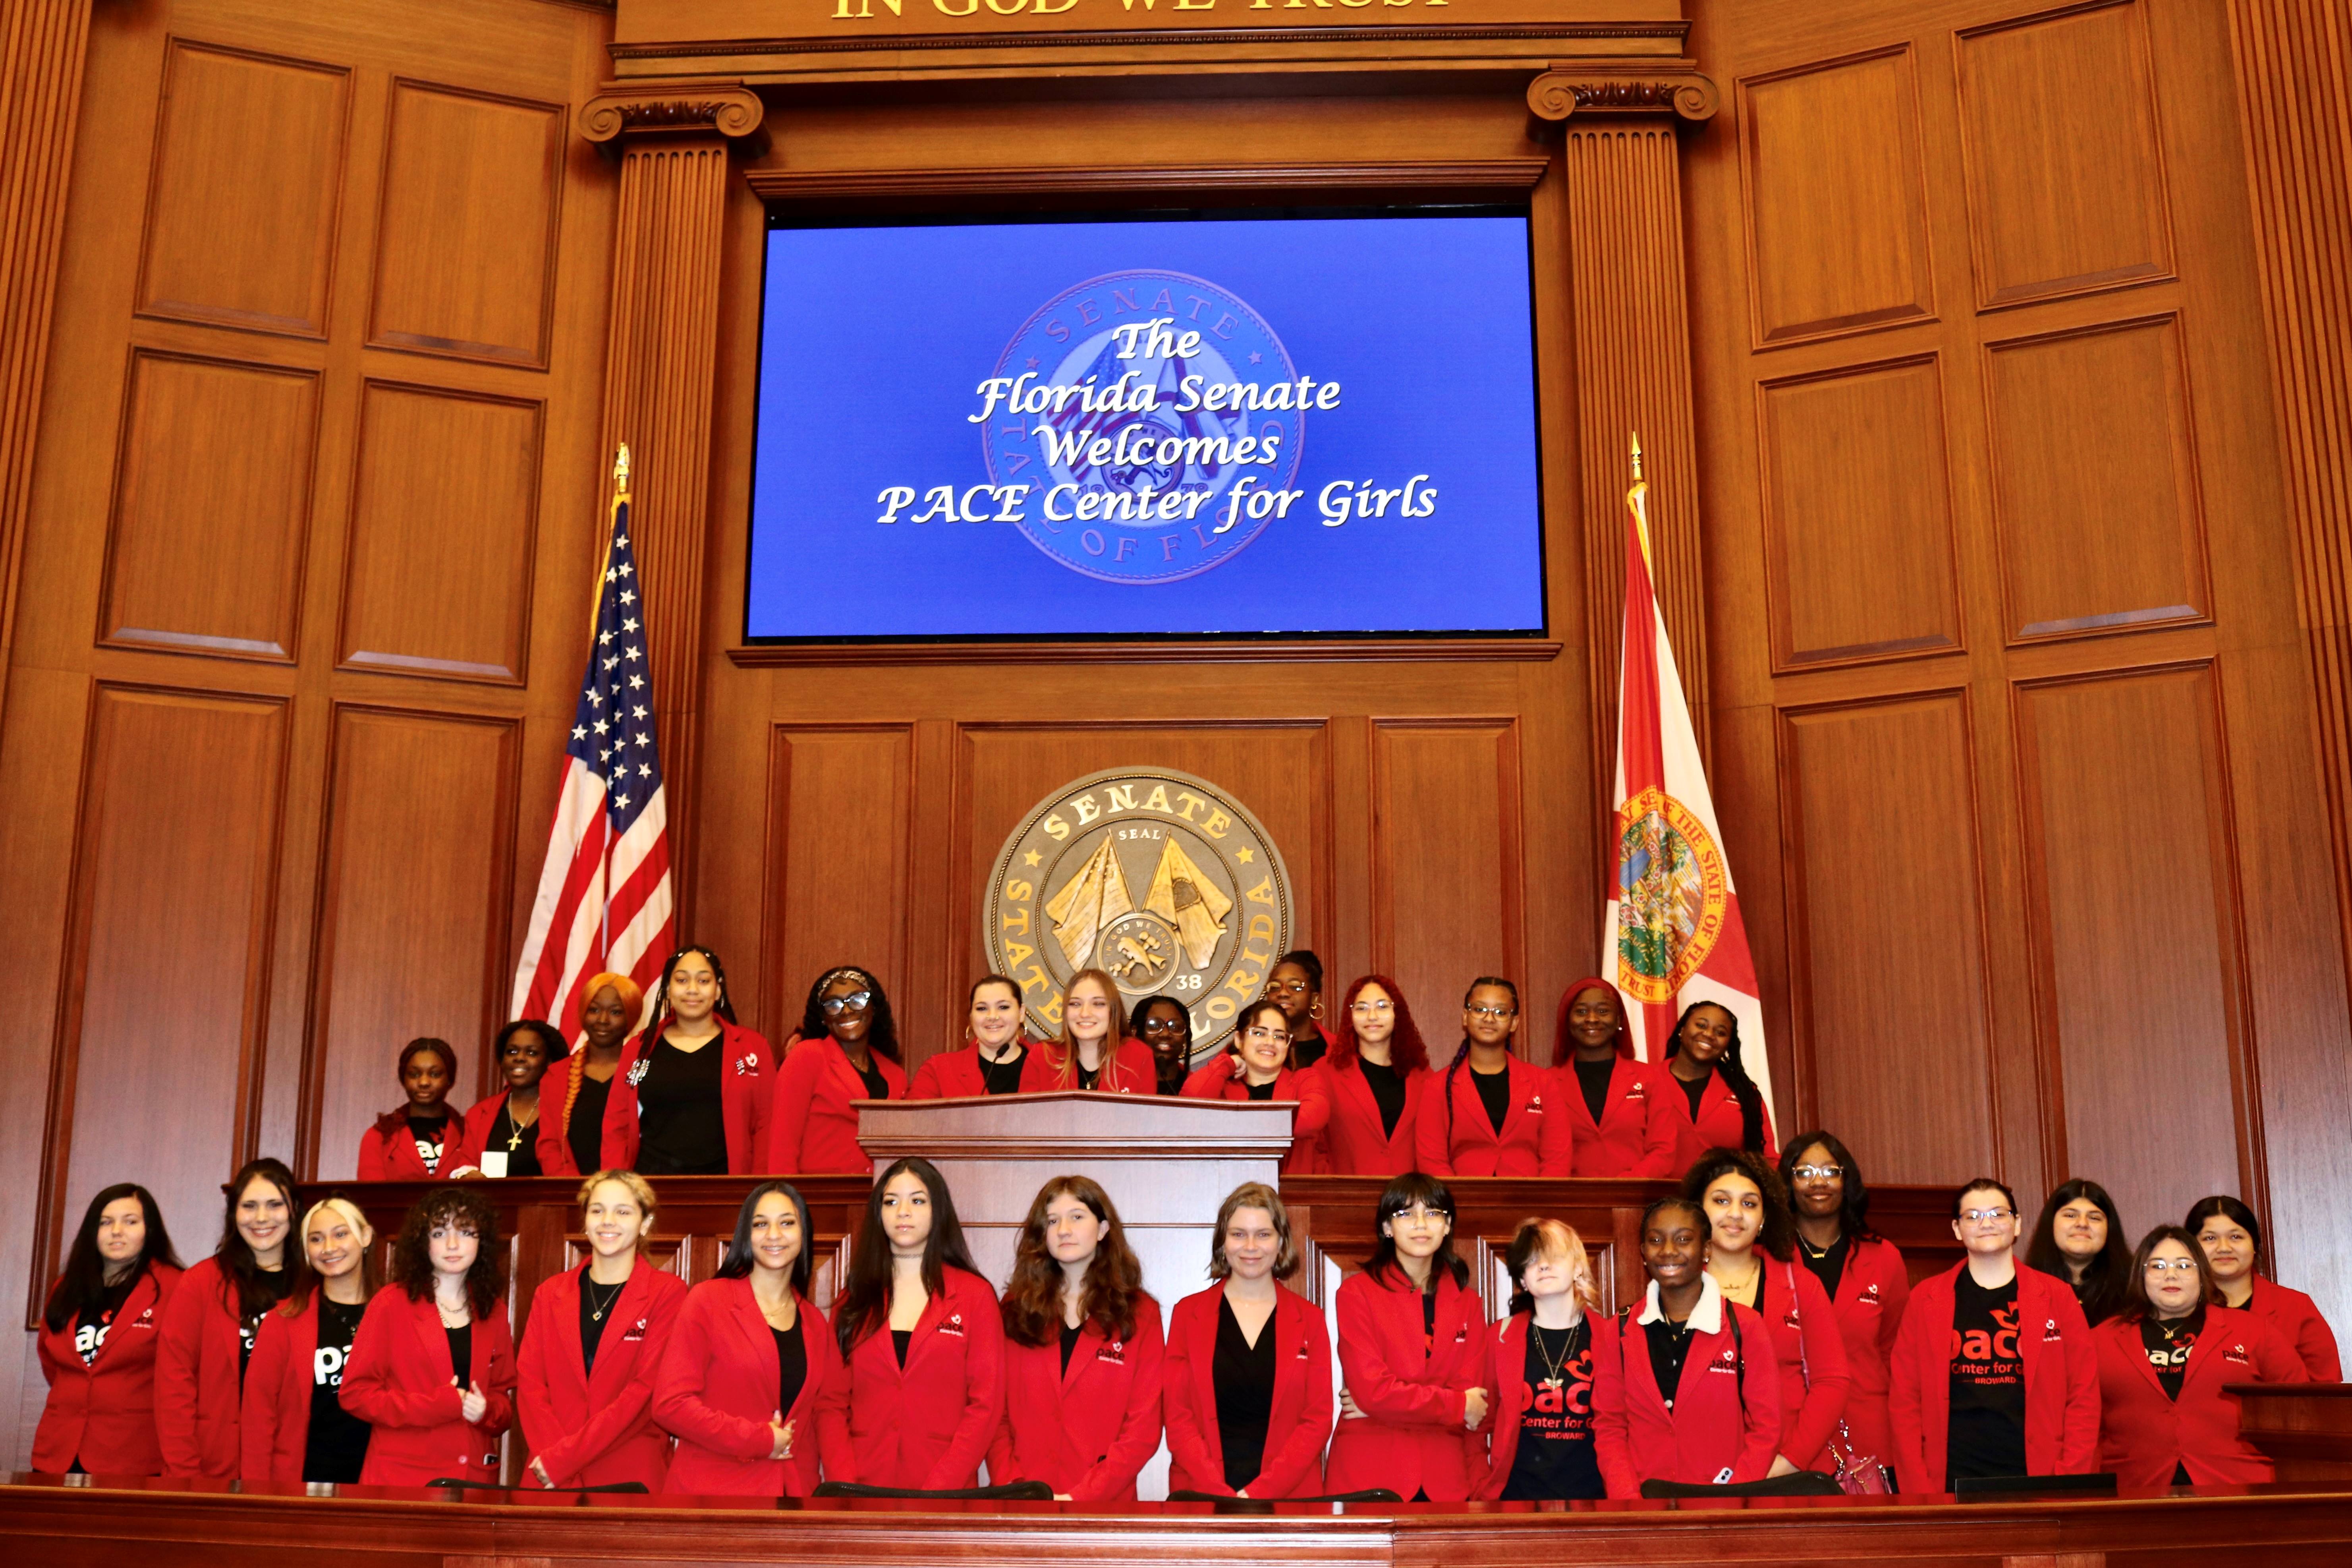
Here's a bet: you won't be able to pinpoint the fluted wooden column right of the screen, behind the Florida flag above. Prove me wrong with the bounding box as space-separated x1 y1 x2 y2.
1526 61 1717 790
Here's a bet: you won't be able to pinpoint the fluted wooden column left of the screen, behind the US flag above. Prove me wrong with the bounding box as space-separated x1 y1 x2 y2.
581 82 767 931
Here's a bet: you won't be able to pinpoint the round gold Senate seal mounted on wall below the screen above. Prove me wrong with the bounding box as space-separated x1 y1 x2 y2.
981 769 1291 1058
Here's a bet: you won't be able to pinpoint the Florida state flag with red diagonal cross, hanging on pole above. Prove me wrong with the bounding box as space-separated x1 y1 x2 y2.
1599 442 1771 1128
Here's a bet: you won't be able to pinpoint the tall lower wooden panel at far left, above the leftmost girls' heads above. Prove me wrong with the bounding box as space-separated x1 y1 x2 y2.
28 684 287 1312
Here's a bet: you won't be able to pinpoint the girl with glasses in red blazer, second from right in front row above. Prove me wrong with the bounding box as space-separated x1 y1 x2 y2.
2091 1225 2310 1491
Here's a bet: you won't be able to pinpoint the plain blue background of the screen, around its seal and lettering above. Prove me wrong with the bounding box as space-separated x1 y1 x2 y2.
745 216 1543 639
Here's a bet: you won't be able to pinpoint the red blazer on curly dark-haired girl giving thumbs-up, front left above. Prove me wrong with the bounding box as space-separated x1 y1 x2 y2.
344 1286 515 1486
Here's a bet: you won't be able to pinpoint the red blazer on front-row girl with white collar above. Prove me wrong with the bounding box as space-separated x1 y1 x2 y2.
1590 1295 1780 1497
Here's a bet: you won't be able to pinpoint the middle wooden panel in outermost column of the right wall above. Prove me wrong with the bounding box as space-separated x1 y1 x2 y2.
1985 315 2213 642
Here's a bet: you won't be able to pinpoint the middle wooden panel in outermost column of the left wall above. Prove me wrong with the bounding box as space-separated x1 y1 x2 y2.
99 348 322 663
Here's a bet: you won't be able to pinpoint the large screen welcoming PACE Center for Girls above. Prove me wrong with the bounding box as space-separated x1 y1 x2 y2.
745 209 1543 642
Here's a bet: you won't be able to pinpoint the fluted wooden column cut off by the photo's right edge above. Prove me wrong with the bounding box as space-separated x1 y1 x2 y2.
2230 0 2352 992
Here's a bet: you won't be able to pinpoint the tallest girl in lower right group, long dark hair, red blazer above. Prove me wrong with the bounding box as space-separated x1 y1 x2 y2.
1780 1133 1910 1469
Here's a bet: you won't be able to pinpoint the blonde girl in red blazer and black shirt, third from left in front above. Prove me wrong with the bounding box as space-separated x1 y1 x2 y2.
238 1197 377 1483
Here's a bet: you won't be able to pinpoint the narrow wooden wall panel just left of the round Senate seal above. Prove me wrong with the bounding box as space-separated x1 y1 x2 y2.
760 724 934 1070
